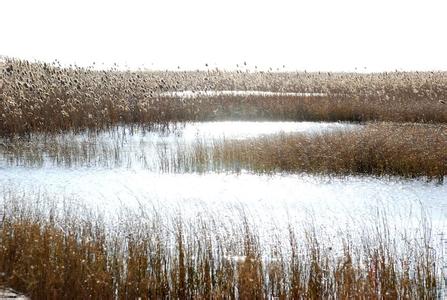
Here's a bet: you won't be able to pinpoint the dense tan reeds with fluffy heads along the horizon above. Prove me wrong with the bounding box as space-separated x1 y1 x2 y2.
0 59 447 136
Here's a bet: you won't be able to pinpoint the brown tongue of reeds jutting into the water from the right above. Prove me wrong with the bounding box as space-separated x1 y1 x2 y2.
194 123 447 182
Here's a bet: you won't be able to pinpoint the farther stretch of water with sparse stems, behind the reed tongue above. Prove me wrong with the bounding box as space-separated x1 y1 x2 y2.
0 122 360 171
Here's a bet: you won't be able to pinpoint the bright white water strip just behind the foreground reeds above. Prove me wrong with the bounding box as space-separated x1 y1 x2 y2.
0 168 447 228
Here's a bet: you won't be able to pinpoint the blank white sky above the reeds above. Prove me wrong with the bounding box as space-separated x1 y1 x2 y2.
0 0 447 71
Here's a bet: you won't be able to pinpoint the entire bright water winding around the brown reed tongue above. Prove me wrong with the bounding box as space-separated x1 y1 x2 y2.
0 122 447 239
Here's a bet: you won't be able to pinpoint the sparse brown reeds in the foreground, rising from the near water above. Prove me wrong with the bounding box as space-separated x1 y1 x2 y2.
0 193 443 299
